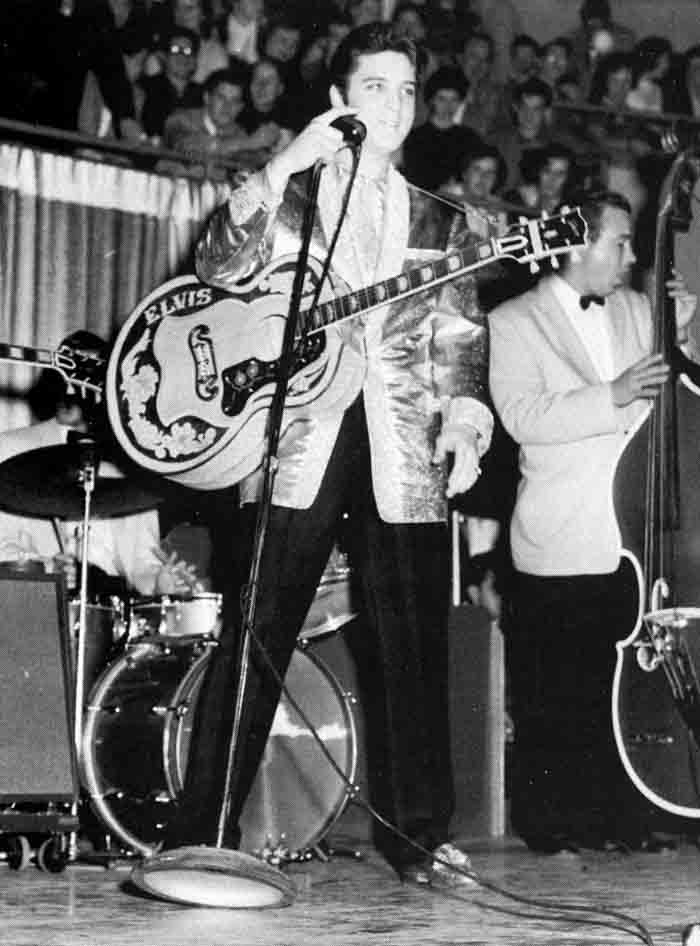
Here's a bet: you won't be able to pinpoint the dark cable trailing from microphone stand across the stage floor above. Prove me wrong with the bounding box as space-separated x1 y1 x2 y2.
239 600 655 946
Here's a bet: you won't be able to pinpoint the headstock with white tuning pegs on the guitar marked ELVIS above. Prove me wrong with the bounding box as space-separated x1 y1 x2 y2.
494 207 587 272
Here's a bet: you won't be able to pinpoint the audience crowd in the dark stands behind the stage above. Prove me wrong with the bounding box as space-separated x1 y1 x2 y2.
0 0 700 196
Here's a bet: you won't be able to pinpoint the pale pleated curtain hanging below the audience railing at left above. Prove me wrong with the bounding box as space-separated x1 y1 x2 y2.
0 144 228 430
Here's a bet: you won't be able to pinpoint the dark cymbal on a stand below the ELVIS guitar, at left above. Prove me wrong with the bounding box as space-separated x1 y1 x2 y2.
0 443 164 520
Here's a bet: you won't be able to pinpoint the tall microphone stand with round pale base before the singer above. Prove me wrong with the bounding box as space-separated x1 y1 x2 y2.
132 161 340 908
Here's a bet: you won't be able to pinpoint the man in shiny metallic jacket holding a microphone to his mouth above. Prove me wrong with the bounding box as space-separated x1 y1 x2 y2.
166 23 492 884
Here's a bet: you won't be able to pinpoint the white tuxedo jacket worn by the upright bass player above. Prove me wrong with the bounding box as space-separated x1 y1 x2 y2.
489 278 652 575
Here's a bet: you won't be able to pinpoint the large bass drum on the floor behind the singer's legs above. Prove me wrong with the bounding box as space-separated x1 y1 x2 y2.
82 639 357 856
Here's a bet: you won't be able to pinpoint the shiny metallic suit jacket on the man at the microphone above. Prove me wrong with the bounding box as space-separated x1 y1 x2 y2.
196 159 492 523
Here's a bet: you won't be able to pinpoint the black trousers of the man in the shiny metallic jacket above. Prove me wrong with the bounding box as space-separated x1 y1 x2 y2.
166 399 454 865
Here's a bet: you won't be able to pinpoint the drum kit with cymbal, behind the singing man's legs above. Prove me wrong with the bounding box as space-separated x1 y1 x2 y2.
0 438 358 864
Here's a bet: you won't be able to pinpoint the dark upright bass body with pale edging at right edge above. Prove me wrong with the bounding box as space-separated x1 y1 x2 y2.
612 372 700 818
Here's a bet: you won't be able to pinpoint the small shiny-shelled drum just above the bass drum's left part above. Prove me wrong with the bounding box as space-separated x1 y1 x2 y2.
129 593 221 641
